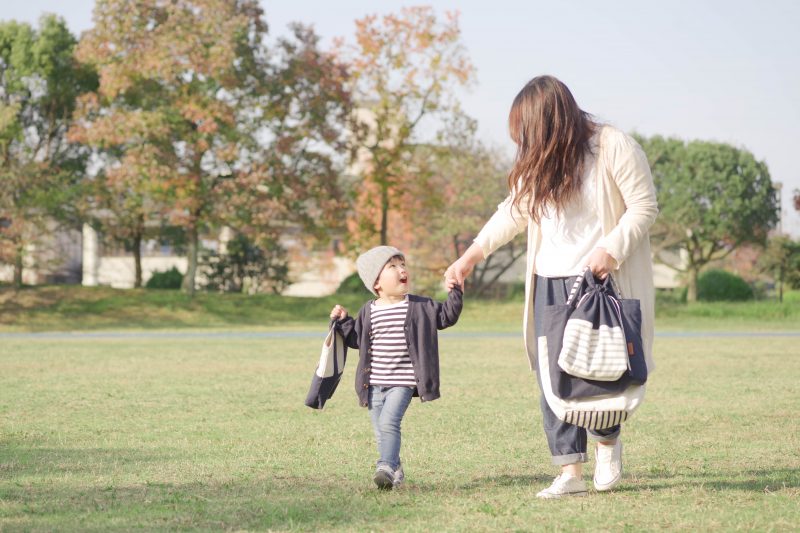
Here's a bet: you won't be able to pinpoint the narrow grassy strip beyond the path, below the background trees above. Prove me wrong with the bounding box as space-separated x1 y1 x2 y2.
0 285 800 332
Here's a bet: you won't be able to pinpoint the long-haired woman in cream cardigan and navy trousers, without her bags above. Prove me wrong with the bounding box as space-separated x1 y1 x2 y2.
445 72 658 498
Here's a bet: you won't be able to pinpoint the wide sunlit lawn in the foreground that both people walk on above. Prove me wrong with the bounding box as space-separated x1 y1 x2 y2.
0 330 800 531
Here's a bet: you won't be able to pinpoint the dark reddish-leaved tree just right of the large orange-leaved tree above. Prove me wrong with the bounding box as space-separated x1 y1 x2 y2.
224 24 351 264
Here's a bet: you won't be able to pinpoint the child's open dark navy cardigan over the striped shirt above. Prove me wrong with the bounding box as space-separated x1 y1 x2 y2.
336 287 463 407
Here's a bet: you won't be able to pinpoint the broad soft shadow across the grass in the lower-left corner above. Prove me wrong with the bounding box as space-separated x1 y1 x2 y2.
0 439 404 531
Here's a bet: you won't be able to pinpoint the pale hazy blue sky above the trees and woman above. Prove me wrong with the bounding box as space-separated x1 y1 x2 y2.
6 0 800 237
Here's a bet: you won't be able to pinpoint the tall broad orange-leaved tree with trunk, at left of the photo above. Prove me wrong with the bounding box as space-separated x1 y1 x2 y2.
71 0 266 294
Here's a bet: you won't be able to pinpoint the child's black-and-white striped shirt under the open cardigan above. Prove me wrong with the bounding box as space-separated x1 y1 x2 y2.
369 297 417 387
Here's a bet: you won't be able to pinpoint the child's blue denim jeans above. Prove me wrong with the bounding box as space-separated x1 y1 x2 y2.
369 386 414 471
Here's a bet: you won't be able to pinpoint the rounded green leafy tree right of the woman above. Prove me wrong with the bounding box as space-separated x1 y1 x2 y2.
637 136 778 302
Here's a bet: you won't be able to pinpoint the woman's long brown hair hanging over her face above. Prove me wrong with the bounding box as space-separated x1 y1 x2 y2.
508 76 597 223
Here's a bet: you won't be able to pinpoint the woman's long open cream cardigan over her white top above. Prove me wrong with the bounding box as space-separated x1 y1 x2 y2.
475 125 658 372
